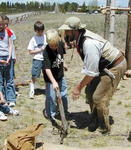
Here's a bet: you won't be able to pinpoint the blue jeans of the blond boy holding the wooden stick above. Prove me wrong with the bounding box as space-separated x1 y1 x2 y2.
45 77 68 118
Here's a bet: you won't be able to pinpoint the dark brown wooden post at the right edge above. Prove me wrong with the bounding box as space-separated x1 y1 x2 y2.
125 0 131 77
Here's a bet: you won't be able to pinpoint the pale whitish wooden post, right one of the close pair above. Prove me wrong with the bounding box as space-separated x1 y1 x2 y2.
109 0 115 45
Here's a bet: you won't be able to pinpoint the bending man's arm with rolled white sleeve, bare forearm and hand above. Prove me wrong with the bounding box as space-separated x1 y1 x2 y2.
72 39 100 99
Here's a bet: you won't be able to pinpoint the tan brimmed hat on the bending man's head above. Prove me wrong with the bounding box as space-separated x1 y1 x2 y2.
58 17 86 30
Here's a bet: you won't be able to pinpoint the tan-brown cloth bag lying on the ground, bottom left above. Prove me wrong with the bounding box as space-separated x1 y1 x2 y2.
6 124 44 150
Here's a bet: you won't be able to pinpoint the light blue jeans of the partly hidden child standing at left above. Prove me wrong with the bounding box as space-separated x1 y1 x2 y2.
5 59 16 102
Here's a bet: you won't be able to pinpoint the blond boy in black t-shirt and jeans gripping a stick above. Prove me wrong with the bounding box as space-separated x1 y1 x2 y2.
43 29 69 120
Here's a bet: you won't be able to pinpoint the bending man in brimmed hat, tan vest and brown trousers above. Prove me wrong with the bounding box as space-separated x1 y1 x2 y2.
59 17 126 134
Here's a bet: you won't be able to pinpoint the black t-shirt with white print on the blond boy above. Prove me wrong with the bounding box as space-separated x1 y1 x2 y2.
43 42 65 82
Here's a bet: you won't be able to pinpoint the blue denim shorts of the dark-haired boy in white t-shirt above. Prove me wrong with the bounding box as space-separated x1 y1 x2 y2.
32 59 43 78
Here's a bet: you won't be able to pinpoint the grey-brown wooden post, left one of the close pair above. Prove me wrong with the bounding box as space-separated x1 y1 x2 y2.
104 0 111 40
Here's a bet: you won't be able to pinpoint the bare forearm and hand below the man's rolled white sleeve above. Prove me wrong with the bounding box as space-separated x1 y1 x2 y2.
72 75 94 100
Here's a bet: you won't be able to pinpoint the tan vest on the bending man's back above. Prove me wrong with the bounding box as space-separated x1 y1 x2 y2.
83 30 121 62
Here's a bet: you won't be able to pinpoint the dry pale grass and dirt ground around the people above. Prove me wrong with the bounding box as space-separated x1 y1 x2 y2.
0 14 131 150
